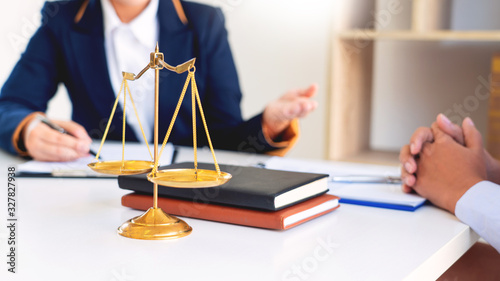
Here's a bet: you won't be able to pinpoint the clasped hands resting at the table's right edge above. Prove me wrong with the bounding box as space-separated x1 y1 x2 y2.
399 114 499 213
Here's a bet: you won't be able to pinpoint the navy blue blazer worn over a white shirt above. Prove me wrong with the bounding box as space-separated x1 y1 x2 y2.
0 0 274 153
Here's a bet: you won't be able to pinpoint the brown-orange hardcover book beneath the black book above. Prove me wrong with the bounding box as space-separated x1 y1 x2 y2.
122 193 340 229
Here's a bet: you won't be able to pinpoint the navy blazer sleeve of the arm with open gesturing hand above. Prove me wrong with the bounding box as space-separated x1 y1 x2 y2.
196 9 282 153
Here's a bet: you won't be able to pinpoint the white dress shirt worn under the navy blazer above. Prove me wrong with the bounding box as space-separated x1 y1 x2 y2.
101 0 159 142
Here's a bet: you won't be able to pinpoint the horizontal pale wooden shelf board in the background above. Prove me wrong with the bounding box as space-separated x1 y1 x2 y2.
339 29 500 41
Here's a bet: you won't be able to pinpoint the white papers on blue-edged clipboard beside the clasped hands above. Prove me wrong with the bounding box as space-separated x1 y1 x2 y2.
265 157 426 211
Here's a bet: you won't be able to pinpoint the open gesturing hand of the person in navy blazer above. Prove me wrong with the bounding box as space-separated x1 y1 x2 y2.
262 84 318 139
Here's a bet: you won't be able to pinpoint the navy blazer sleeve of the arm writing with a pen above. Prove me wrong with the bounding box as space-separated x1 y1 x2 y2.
0 4 60 153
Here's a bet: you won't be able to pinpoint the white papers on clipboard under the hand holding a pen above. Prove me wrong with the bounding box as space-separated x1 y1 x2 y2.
17 142 175 178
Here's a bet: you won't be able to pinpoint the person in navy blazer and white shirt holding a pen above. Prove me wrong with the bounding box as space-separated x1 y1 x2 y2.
0 0 317 161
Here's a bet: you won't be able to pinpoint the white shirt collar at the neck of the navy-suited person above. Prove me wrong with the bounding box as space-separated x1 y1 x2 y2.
101 0 159 48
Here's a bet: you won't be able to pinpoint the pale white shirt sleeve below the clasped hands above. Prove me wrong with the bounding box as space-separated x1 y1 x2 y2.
455 181 500 253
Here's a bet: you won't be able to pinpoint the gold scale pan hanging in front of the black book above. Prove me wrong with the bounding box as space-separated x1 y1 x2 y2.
148 169 232 188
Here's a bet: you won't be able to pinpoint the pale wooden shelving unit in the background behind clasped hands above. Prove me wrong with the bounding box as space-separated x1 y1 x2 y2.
328 0 500 165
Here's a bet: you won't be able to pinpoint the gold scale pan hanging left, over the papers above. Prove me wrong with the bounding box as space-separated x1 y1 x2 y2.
87 160 154 175
